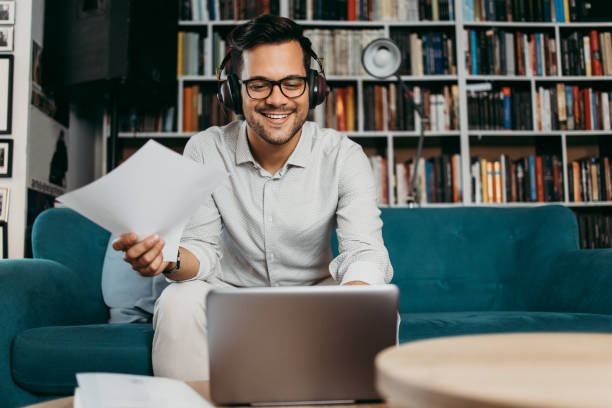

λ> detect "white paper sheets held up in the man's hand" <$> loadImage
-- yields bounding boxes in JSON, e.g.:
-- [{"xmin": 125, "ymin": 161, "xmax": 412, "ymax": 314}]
[{"xmin": 57, "ymin": 140, "xmax": 227, "ymax": 261}]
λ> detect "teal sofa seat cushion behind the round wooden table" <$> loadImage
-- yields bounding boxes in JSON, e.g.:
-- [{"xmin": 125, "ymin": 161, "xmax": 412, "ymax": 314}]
[{"xmin": 399, "ymin": 311, "xmax": 612, "ymax": 343}]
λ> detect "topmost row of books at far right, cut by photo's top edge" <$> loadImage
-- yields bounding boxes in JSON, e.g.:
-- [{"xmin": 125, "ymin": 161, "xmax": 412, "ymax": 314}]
[{"xmin": 463, "ymin": 0, "xmax": 609, "ymax": 23}]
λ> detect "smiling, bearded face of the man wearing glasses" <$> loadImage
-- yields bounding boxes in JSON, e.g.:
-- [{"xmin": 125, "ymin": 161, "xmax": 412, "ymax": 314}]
[{"xmin": 240, "ymin": 41, "xmax": 308, "ymax": 145}]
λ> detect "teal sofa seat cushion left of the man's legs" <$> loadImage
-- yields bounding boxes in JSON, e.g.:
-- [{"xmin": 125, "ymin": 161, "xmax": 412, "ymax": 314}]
[{"xmin": 12, "ymin": 324, "xmax": 153, "ymax": 395}]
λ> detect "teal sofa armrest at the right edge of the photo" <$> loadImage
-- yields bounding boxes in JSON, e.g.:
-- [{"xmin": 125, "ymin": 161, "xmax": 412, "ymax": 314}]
[{"xmin": 549, "ymin": 249, "xmax": 612, "ymax": 314}]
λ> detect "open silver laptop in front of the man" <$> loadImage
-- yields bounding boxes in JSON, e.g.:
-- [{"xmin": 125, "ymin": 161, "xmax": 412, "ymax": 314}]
[{"xmin": 206, "ymin": 285, "xmax": 399, "ymax": 405}]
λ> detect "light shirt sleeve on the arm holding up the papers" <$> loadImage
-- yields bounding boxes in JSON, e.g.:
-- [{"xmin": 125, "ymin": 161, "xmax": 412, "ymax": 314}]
[{"xmin": 169, "ymin": 138, "xmax": 223, "ymax": 281}]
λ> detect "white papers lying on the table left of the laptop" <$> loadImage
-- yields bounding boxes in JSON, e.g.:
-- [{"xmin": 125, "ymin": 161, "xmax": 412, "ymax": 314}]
[{"xmin": 75, "ymin": 373, "xmax": 213, "ymax": 408}]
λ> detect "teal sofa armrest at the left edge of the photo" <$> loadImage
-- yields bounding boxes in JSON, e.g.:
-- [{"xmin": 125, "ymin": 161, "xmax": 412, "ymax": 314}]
[{"xmin": 0, "ymin": 259, "xmax": 108, "ymax": 406}]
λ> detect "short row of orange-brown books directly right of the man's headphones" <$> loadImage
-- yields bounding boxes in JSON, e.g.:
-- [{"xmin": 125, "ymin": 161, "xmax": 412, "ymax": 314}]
[{"xmin": 309, "ymin": 85, "xmax": 357, "ymax": 132}]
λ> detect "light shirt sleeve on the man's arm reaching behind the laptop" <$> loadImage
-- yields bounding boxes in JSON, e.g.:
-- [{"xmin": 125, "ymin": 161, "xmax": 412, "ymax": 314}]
[{"xmin": 329, "ymin": 143, "xmax": 393, "ymax": 285}]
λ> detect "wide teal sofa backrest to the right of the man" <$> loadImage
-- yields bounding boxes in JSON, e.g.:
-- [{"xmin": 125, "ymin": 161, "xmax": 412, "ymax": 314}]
[{"xmin": 381, "ymin": 206, "xmax": 578, "ymax": 312}]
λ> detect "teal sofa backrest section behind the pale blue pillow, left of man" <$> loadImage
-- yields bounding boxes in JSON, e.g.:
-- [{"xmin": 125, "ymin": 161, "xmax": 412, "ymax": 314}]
[{"xmin": 32, "ymin": 208, "xmax": 110, "ymax": 320}]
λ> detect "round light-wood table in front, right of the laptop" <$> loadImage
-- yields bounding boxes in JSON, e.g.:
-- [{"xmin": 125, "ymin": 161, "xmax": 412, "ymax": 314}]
[{"xmin": 375, "ymin": 333, "xmax": 612, "ymax": 408}]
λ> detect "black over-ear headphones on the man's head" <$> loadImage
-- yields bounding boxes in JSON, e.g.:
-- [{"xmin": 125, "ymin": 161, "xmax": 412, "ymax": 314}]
[{"xmin": 217, "ymin": 50, "xmax": 329, "ymax": 115}]
